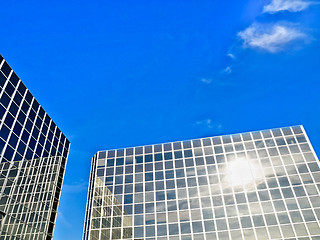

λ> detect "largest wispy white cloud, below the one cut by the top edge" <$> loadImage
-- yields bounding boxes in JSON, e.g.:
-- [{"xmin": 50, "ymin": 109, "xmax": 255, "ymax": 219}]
[{"xmin": 238, "ymin": 23, "xmax": 307, "ymax": 53}]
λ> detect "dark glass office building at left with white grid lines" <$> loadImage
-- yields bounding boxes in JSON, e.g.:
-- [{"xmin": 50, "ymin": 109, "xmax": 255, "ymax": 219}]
[{"xmin": 0, "ymin": 55, "xmax": 70, "ymax": 240}]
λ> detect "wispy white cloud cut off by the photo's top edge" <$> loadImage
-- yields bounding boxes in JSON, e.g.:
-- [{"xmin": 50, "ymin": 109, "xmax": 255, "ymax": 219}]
[{"xmin": 263, "ymin": 0, "xmax": 314, "ymax": 14}]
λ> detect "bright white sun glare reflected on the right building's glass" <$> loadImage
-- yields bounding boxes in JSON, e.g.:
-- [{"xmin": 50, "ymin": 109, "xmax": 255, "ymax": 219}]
[{"xmin": 226, "ymin": 158, "xmax": 262, "ymax": 187}]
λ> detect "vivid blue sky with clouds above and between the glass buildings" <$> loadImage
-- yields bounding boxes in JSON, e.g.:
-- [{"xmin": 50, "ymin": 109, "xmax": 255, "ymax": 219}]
[{"xmin": 0, "ymin": 0, "xmax": 320, "ymax": 240}]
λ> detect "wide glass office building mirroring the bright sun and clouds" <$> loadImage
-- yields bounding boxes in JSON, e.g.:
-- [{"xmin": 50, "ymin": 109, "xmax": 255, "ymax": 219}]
[{"xmin": 83, "ymin": 126, "xmax": 320, "ymax": 240}]
